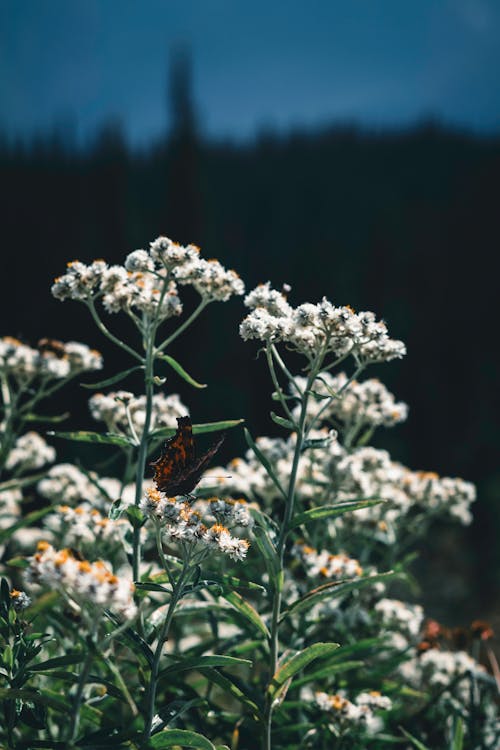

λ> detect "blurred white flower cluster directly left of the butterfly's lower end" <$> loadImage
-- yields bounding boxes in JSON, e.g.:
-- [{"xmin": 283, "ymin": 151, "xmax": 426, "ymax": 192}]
[{"xmin": 35, "ymin": 464, "xmax": 143, "ymax": 512}]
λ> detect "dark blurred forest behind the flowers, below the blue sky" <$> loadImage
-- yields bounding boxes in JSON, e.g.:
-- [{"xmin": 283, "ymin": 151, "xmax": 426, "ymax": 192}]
[{"xmin": 0, "ymin": 50, "xmax": 500, "ymax": 630}]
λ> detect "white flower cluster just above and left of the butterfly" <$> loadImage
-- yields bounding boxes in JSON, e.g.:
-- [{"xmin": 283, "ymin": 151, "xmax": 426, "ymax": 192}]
[{"xmin": 89, "ymin": 391, "xmax": 189, "ymax": 434}]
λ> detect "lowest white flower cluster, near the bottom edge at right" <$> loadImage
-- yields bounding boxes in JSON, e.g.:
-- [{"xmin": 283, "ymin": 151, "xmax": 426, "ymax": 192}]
[{"xmin": 315, "ymin": 690, "xmax": 392, "ymax": 734}]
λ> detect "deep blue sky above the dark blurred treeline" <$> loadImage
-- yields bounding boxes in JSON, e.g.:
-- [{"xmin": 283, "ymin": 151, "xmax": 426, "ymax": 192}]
[{"xmin": 0, "ymin": 0, "xmax": 500, "ymax": 144}]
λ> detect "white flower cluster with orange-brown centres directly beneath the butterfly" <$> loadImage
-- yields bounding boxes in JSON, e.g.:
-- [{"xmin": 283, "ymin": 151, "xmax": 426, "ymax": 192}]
[{"xmin": 139, "ymin": 489, "xmax": 250, "ymax": 560}]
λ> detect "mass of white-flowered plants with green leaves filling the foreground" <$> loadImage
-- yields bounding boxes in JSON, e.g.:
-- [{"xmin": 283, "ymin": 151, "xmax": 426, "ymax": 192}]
[{"xmin": 0, "ymin": 237, "xmax": 500, "ymax": 750}]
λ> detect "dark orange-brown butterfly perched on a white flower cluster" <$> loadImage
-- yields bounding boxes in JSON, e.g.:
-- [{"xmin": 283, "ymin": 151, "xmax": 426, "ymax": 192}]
[{"xmin": 151, "ymin": 417, "xmax": 226, "ymax": 497}]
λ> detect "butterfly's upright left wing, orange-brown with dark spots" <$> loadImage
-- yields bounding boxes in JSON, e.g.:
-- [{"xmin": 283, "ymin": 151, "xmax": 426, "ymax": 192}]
[{"xmin": 151, "ymin": 417, "xmax": 195, "ymax": 495}]
